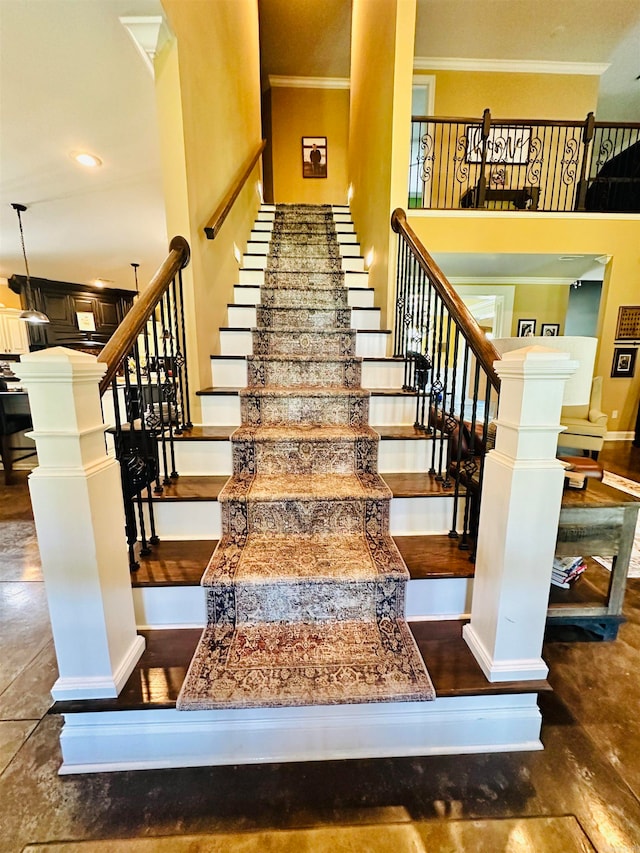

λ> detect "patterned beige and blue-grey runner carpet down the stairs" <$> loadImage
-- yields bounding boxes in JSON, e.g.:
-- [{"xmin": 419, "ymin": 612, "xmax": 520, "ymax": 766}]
[{"xmin": 177, "ymin": 205, "xmax": 435, "ymax": 710}]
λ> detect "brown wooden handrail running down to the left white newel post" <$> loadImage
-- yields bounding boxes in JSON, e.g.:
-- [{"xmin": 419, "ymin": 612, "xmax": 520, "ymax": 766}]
[{"xmin": 98, "ymin": 237, "xmax": 191, "ymax": 396}]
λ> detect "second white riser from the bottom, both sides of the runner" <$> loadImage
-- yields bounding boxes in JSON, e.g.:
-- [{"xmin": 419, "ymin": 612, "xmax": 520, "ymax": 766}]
[{"xmin": 133, "ymin": 572, "xmax": 473, "ymax": 630}]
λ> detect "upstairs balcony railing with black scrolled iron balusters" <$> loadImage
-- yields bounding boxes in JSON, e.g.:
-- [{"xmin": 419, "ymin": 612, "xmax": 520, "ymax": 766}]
[{"xmin": 408, "ymin": 109, "xmax": 640, "ymax": 213}]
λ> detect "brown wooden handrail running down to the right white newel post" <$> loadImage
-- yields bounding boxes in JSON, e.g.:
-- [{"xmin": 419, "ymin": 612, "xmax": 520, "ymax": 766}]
[{"xmin": 391, "ymin": 207, "xmax": 500, "ymax": 391}]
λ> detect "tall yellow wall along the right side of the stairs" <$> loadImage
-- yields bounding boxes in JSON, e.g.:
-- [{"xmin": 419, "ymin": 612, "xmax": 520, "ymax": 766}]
[{"xmin": 349, "ymin": 0, "xmax": 416, "ymax": 332}]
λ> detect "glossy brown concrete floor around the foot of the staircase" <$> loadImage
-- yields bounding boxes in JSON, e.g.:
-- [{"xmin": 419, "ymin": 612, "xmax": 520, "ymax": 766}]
[{"xmin": 0, "ymin": 443, "xmax": 640, "ymax": 853}]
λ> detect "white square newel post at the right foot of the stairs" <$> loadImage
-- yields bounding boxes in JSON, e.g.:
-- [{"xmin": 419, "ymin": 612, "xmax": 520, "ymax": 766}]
[{"xmin": 463, "ymin": 346, "xmax": 577, "ymax": 681}]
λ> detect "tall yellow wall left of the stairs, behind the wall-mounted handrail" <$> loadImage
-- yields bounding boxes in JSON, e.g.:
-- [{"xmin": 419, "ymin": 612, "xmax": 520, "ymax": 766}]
[{"xmin": 156, "ymin": 0, "xmax": 261, "ymax": 404}]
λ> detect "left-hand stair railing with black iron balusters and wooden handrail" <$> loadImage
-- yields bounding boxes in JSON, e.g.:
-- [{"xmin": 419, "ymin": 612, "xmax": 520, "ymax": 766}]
[{"xmin": 98, "ymin": 237, "xmax": 192, "ymax": 571}]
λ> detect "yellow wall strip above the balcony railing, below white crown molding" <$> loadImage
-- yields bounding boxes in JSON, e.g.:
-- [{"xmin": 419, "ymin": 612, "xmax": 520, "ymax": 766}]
[{"xmin": 416, "ymin": 71, "xmax": 599, "ymax": 120}]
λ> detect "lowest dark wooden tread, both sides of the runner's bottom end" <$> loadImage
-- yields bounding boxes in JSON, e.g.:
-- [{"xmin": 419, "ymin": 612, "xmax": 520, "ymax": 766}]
[{"xmin": 49, "ymin": 620, "xmax": 551, "ymax": 714}]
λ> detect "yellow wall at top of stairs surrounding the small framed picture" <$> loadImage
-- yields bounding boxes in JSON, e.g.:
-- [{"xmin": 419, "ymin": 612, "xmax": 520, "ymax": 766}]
[{"xmin": 271, "ymin": 86, "xmax": 349, "ymax": 204}]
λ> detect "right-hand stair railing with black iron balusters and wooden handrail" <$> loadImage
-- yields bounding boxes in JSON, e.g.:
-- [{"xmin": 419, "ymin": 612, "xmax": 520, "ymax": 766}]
[{"xmin": 391, "ymin": 208, "xmax": 500, "ymax": 557}]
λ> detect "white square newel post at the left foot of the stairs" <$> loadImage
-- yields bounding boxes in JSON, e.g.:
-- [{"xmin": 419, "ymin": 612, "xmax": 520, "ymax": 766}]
[{"xmin": 20, "ymin": 347, "xmax": 144, "ymax": 700}]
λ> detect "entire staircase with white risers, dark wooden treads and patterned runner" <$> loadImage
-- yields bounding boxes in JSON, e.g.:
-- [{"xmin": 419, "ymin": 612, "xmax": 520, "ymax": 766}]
[{"xmin": 54, "ymin": 201, "xmax": 546, "ymax": 773}]
